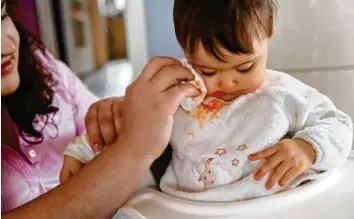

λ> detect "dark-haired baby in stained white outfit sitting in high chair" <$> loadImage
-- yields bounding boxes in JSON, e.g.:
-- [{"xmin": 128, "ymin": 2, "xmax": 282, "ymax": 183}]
[{"xmin": 59, "ymin": 0, "xmax": 353, "ymax": 202}]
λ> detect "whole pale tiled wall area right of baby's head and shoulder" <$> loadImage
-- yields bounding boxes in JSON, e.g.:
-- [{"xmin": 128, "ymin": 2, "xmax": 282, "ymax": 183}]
[{"xmin": 268, "ymin": 0, "xmax": 354, "ymax": 149}]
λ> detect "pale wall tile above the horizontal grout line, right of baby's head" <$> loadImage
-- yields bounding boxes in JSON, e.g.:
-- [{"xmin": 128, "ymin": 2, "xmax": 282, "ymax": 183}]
[{"xmin": 269, "ymin": 0, "xmax": 354, "ymax": 69}]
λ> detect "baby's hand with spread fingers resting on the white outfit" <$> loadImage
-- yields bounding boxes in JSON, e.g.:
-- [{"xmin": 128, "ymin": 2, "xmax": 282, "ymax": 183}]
[{"xmin": 248, "ymin": 139, "xmax": 316, "ymax": 189}]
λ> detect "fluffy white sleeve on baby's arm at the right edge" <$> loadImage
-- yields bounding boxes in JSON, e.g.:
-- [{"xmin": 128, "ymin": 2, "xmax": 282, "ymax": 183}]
[{"xmin": 285, "ymin": 79, "xmax": 353, "ymax": 171}]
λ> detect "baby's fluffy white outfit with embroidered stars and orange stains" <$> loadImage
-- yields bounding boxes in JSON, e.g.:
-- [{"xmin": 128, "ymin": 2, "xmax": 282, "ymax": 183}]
[{"xmin": 65, "ymin": 60, "xmax": 353, "ymax": 202}]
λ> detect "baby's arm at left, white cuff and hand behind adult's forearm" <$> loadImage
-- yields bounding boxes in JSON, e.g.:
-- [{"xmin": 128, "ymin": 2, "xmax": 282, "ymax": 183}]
[{"xmin": 59, "ymin": 132, "xmax": 97, "ymax": 183}]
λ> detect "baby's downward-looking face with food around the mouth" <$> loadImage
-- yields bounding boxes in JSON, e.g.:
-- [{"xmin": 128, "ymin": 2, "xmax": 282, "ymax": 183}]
[{"xmin": 185, "ymin": 39, "xmax": 269, "ymax": 101}]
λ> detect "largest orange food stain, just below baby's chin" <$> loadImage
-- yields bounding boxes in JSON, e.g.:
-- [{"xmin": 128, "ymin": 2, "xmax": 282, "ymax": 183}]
[{"xmin": 192, "ymin": 99, "xmax": 225, "ymax": 128}]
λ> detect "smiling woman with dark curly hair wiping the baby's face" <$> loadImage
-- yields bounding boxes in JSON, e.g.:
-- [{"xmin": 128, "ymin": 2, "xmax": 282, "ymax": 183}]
[{"xmin": 1, "ymin": 1, "xmax": 197, "ymax": 219}]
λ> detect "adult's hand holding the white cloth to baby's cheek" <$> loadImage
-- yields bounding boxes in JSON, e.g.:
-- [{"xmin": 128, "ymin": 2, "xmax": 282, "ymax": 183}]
[{"xmin": 119, "ymin": 57, "xmax": 199, "ymax": 161}]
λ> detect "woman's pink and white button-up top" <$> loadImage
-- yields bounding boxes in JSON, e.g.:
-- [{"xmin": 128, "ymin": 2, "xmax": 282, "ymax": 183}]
[{"xmin": 1, "ymin": 55, "xmax": 97, "ymax": 213}]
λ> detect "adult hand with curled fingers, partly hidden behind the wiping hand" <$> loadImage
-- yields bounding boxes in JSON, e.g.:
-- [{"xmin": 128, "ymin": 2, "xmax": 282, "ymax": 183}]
[{"xmin": 85, "ymin": 97, "xmax": 123, "ymax": 152}]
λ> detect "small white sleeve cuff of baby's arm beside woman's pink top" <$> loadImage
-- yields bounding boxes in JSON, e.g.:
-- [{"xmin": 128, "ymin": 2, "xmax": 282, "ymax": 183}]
[{"xmin": 64, "ymin": 132, "xmax": 97, "ymax": 164}]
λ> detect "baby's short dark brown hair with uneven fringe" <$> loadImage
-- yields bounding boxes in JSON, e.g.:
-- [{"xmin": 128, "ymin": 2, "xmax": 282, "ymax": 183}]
[{"xmin": 173, "ymin": 0, "xmax": 277, "ymax": 62}]
